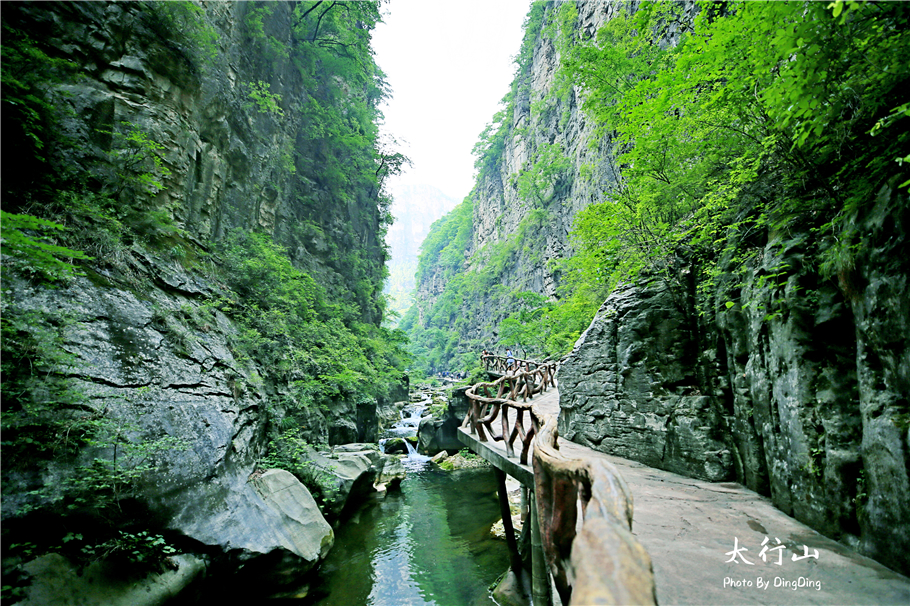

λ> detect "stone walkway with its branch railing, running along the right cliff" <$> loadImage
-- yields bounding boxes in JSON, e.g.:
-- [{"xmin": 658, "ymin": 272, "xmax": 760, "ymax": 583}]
[{"xmin": 458, "ymin": 356, "xmax": 910, "ymax": 606}]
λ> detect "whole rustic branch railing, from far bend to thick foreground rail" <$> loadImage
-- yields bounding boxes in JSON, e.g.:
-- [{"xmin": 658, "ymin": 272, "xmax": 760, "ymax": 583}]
[{"xmin": 462, "ymin": 355, "xmax": 657, "ymax": 605}]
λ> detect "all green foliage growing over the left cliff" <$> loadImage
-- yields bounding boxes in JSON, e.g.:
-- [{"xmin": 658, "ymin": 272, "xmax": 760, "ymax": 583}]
[{"xmin": 0, "ymin": 2, "xmax": 407, "ymax": 597}]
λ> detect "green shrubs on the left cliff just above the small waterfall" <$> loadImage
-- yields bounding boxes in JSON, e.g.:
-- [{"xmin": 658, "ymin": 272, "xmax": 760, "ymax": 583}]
[{"xmin": 219, "ymin": 230, "xmax": 407, "ymax": 415}]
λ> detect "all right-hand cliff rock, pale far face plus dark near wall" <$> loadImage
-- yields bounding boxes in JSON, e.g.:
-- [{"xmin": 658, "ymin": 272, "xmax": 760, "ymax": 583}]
[{"xmin": 405, "ymin": 2, "xmax": 910, "ymax": 571}]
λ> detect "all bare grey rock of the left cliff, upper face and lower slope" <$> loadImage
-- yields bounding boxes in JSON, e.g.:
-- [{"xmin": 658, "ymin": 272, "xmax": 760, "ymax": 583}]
[{"xmin": 3, "ymin": 2, "xmax": 398, "ymax": 588}]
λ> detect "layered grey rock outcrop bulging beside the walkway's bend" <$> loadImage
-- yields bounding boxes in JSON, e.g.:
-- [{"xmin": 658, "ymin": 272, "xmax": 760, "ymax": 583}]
[{"xmin": 558, "ymin": 282, "xmax": 735, "ymax": 481}]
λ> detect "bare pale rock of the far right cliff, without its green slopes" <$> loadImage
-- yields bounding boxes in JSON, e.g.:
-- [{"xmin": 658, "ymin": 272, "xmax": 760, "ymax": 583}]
[{"xmin": 416, "ymin": 0, "xmax": 621, "ymax": 346}]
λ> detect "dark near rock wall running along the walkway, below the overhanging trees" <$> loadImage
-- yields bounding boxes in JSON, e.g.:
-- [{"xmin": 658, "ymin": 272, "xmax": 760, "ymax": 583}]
[{"xmin": 558, "ymin": 179, "xmax": 910, "ymax": 573}]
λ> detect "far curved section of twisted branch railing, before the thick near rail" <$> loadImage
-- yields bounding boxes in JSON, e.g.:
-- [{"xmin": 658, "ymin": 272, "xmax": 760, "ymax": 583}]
[{"xmin": 461, "ymin": 364, "xmax": 556, "ymax": 465}]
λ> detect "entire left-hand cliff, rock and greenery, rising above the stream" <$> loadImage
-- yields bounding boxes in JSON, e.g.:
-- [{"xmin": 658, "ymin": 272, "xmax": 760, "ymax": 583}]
[{"xmin": 3, "ymin": 2, "xmax": 400, "ymax": 588}]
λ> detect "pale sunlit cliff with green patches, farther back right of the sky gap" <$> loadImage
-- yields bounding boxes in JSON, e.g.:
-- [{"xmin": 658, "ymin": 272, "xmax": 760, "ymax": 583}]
[{"xmin": 402, "ymin": 1, "xmax": 624, "ymax": 368}]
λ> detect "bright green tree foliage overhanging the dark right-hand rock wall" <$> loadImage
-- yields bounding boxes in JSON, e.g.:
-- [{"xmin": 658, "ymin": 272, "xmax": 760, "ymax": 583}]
[{"xmin": 563, "ymin": 2, "xmax": 910, "ymax": 318}]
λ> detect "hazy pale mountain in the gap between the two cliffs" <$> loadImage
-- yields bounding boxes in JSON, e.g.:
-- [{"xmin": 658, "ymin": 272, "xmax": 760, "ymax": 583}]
[{"xmin": 385, "ymin": 185, "xmax": 458, "ymax": 324}]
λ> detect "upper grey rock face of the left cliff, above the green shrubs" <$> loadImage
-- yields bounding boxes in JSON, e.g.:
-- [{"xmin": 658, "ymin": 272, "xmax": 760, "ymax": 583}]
[{"xmin": 10, "ymin": 2, "xmax": 385, "ymax": 322}]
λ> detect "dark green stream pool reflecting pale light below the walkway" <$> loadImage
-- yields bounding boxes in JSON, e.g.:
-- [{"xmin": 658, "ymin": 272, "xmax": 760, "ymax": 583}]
[{"xmin": 307, "ymin": 455, "xmax": 509, "ymax": 606}]
